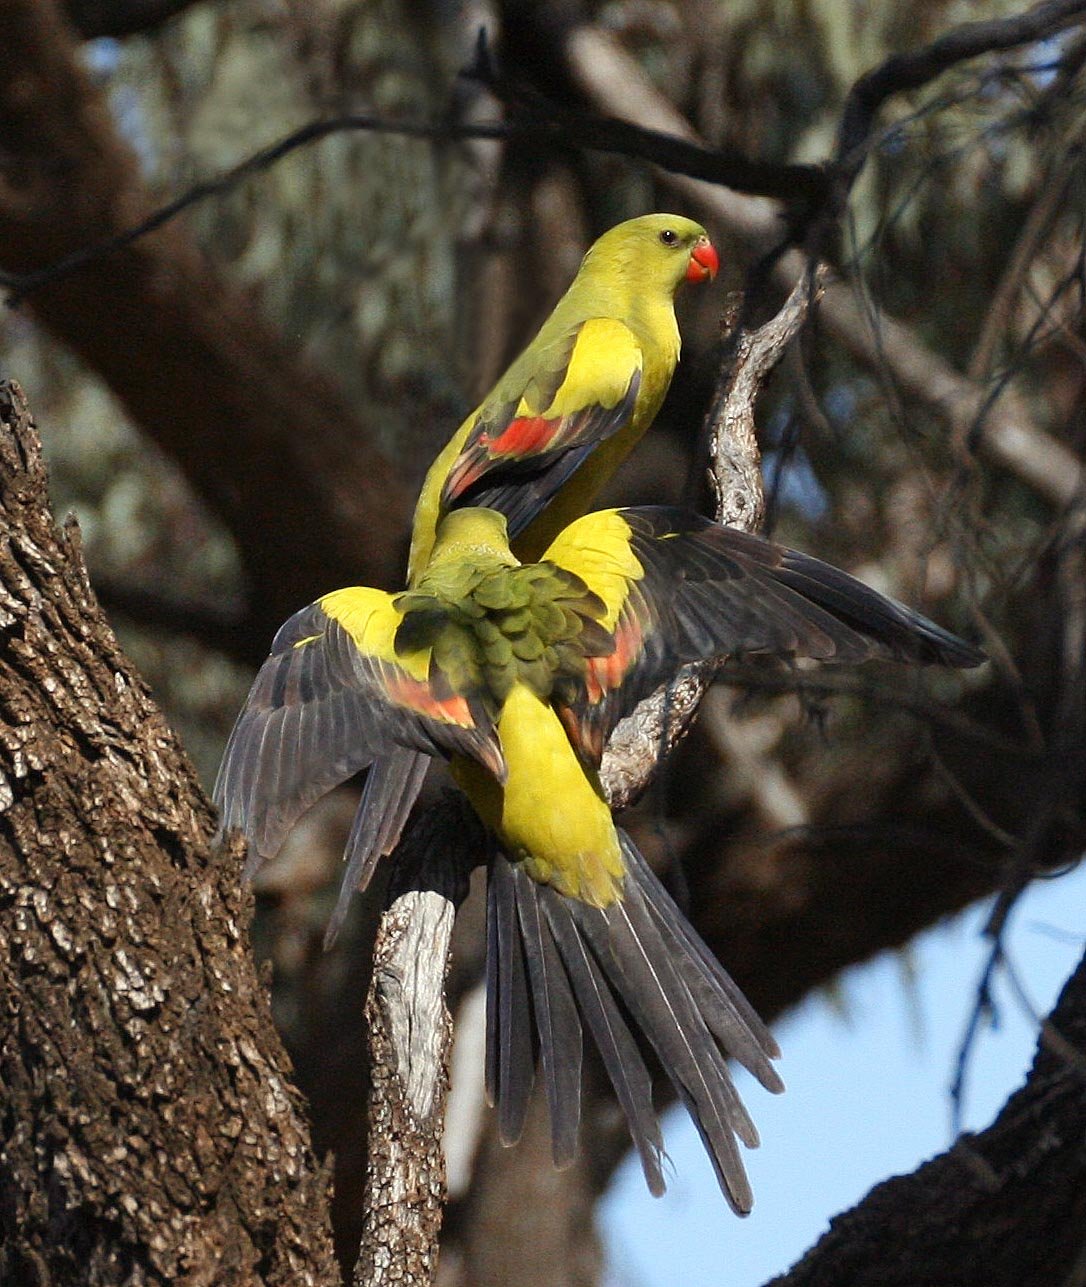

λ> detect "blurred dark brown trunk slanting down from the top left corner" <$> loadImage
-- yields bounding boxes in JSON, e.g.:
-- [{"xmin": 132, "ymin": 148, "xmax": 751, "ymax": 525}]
[{"xmin": 0, "ymin": 0, "xmax": 409, "ymax": 648}]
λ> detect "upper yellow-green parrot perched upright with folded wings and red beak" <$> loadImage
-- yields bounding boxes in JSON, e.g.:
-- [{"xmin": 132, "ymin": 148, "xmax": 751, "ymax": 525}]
[{"xmin": 347, "ymin": 215, "xmax": 719, "ymax": 900}]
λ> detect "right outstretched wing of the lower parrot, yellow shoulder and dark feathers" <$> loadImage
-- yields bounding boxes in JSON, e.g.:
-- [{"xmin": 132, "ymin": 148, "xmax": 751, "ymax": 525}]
[{"xmin": 544, "ymin": 507, "xmax": 984, "ymax": 762}]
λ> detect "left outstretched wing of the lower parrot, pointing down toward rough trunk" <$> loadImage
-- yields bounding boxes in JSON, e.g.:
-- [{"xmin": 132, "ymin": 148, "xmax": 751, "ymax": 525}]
[{"xmin": 214, "ymin": 587, "xmax": 504, "ymax": 875}]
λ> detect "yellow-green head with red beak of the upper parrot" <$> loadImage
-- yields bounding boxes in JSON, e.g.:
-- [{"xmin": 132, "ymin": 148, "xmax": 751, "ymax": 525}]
[{"xmin": 582, "ymin": 215, "xmax": 721, "ymax": 295}]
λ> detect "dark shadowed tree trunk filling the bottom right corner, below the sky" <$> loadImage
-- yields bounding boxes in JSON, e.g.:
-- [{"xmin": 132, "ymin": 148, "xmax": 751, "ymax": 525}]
[{"xmin": 773, "ymin": 958, "xmax": 1086, "ymax": 1287}]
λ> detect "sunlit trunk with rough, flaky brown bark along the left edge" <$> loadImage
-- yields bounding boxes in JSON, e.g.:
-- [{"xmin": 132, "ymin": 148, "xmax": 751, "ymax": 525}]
[{"xmin": 0, "ymin": 385, "xmax": 340, "ymax": 1287}]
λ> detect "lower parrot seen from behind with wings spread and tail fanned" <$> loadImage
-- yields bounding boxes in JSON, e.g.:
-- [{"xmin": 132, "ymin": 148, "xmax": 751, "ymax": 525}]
[{"xmin": 215, "ymin": 507, "xmax": 983, "ymax": 1212}]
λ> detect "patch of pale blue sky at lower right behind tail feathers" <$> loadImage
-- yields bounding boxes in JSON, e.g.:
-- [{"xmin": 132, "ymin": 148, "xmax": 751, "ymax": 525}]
[{"xmin": 601, "ymin": 865, "xmax": 1086, "ymax": 1287}]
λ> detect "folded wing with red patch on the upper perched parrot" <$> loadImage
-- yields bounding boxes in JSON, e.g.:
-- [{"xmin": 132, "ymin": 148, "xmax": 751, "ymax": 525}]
[{"xmin": 441, "ymin": 318, "xmax": 642, "ymax": 537}]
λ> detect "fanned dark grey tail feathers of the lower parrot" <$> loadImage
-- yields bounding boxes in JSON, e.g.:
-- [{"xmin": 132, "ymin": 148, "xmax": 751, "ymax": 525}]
[{"xmin": 486, "ymin": 833, "xmax": 784, "ymax": 1214}]
